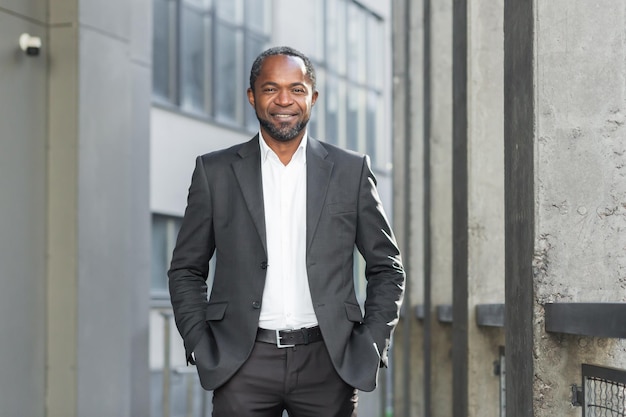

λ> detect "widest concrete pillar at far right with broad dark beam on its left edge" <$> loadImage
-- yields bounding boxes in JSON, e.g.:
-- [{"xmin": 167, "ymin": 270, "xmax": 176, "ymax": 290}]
[{"xmin": 504, "ymin": 0, "xmax": 626, "ymax": 417}]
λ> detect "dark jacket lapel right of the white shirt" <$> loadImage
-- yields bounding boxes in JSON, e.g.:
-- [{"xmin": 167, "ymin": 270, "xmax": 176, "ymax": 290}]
[{"xmin": 306, "ymin": 136, "xmax": 333, "ymax": 252}]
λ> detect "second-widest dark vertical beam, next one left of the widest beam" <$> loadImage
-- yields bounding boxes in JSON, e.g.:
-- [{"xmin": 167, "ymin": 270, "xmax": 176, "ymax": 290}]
[{"xmin": 452, "ymin": 0, "xmax": 468, "ymax": 417}]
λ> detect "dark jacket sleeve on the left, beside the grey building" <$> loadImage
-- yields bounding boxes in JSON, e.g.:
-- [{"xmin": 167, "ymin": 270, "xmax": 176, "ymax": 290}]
[{"xmin": 168, "ymin": 157, "xmax": 215, "ymax": 363}]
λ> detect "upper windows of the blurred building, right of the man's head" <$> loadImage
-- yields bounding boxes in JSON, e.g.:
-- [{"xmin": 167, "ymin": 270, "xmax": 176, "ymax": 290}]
[{"xmin": 315, "ymin": 0, "xmax": 386, "ymax": 167}]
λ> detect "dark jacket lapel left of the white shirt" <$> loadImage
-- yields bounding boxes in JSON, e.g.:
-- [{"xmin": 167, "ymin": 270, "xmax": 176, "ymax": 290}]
[{"xmin": 232, "ymin": 135, "xmax": 267, "ymax": 254}]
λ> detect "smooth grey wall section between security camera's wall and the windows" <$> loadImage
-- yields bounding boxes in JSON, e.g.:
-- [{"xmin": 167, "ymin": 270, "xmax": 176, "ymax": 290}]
[{"xmin": 46, "ymin": 0, "xmax": 152, "ymax": 417}]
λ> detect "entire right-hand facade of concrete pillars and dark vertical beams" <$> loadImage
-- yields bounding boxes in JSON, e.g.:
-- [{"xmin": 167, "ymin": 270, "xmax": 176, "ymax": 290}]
[{"xmin": 393, "ymin": 0, "xmax": 626, "ymax": 417}]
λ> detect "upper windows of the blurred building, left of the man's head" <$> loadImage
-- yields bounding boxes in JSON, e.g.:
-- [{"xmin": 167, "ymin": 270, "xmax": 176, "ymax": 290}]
[{"xmin": 152, "ymin": 0, "xmax": 271, "ymax": 131}]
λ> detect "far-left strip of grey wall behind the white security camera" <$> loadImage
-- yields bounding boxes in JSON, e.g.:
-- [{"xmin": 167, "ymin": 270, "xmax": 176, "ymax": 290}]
[{"xmin": 0, "ymin": 0, "xmax": 48, "ymax": 417}]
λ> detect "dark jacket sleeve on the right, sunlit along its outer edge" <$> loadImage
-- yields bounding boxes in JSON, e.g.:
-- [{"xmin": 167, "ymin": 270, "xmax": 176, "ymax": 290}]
[{"xmin": 356, "ymin": 157, "xmax": 405, "ymax": 366}]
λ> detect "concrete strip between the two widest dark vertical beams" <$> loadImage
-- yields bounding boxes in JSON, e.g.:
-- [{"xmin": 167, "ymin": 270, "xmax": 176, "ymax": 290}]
[{"xmin": 467, "ymin": 0, "xmax": 504, "ymax": 417}]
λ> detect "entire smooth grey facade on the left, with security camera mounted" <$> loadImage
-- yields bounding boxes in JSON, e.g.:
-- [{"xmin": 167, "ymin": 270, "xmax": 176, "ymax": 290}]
[{"xmin": 0, "ymin": 0, "xmax": 152, "ymax": 417}]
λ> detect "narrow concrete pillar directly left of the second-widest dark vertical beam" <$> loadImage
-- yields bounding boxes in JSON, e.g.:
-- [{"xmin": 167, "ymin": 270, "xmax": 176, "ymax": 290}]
[{"xmin": 423, "ymin": 0, "xmax": 453, "ymax": 417}]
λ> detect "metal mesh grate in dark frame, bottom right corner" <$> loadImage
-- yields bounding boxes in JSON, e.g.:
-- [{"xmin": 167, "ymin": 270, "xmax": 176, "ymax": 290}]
[{"xmin": 582, "ymin": 364, "xmax": 626, "ymax": 417}]
